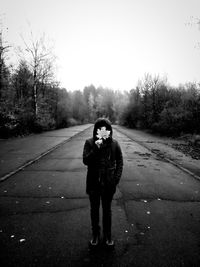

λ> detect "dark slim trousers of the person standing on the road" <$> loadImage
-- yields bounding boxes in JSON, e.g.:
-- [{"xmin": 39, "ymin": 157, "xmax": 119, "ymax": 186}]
[{"xmin": 89, "ymin": 192, "xmax": 114, "ymax": 239}]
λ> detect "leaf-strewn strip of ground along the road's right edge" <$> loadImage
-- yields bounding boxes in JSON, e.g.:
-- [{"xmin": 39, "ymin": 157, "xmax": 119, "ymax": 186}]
[{"xmin": 114, "ymin": 126, "xmax": 200, "ymax": 180}]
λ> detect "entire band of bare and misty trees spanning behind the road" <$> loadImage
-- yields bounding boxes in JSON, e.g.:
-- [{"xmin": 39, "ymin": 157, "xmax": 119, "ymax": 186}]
[{"xmin": 0, "ymin": 28, "xmax": 200, "ymax": 138}]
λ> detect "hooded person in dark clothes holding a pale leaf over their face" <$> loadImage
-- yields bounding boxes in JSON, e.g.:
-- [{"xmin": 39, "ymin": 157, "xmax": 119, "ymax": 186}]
[{"xmin": 83, "ymin": 118, "xmax": 123, "ymax": 246}]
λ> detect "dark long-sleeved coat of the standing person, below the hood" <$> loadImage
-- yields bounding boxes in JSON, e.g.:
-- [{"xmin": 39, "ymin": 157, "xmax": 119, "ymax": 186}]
[{"xmin": 83, "ymin": 138, "xmax": 123, "ymax": 194}]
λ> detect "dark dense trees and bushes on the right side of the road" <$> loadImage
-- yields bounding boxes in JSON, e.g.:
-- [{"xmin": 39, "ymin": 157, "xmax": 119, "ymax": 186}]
[{"xmin": 122, "ymin": 74, "xmax": 200, "ymax": 136}]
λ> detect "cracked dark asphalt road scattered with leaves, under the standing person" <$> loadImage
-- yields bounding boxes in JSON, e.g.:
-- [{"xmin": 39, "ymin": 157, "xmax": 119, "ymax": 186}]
[{"xmin": 0, "ymin": 127, "xmax": 200, "ymax": 267}]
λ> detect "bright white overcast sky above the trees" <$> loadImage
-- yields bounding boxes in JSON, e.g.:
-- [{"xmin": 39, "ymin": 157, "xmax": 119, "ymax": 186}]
[{"xmin": 0, "ymin": 0, "xmax": 200, "ymax": 90}]
